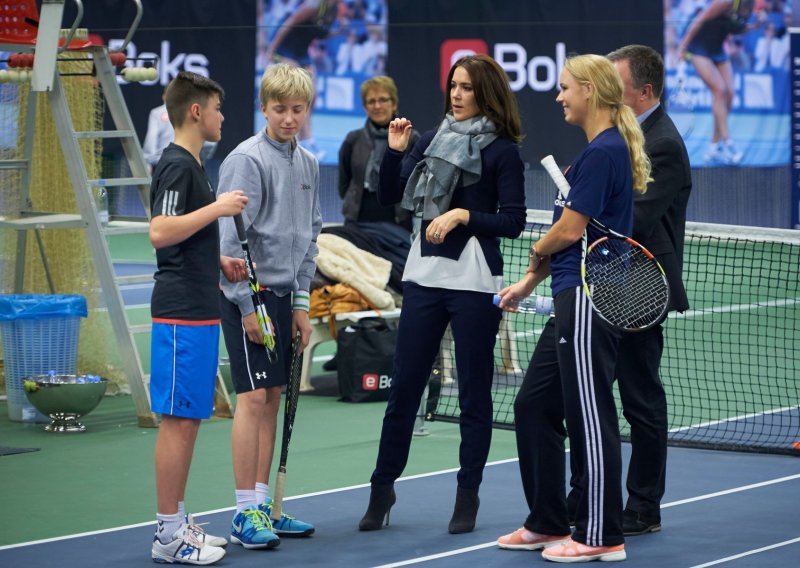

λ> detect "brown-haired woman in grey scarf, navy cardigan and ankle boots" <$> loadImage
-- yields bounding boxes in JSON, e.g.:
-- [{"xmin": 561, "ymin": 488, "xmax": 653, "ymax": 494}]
[{"xmin": 359, "ymin": 55, "xmax": 525, "ymax": 533}]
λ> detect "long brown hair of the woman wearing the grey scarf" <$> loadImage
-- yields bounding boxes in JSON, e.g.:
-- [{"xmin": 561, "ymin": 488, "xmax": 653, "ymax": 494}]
[{"xmin": 444, "ymin": 53, "xmax": 522, "ymax": 143}]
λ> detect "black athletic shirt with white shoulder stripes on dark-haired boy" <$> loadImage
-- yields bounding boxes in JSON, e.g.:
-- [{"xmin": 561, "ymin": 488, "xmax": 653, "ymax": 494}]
[{"xmin": 150, "ymin": 144, "xmax": 220, "ymax": 321}]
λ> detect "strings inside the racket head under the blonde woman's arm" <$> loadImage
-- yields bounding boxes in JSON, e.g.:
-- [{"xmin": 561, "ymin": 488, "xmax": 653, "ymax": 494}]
[{"xmin": 585, "ymin": 239, "xmax": 669, "ymax": 330}]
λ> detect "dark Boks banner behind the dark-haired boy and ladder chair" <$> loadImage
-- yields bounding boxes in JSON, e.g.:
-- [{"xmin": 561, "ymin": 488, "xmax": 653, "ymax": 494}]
[{"xmin": 81, "ymin": 0, "xmax": 256, "ymax": 158}]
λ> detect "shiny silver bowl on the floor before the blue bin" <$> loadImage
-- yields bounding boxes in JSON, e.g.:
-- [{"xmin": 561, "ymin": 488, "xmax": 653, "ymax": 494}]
[{"xmin": 22, "ymin": 375, "xmax": 108, "ymax": 432}]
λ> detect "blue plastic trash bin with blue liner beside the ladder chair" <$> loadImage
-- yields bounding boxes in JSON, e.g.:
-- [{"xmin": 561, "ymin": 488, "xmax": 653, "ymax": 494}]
[{"xmin": 0, "ymin": 294, "xmax": 88, "ymax": 422}]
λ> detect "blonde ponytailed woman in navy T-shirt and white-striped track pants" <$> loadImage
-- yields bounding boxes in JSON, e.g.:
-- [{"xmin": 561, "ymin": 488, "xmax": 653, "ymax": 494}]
[{"xmin": 498, "ymin": 55, "xmax": 650, "ymax": 562}]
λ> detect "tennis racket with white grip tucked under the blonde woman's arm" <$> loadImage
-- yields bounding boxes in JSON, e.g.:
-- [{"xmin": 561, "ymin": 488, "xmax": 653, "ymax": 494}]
[{"xmin": 542, "ymin": 156, "xmax": 669, "ymax": 331}]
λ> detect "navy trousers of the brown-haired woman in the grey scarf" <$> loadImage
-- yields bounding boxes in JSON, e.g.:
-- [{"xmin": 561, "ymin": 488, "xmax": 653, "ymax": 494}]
[{"xmin": 371, "ymin": 282, "xmax": 502, "ymax": 489}]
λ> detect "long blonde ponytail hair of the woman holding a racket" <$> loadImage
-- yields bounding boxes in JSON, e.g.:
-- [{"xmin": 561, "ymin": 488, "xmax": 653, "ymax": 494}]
[{"xmin": 564, "ymin": 54, "xmax": 653, "ymax": 193}]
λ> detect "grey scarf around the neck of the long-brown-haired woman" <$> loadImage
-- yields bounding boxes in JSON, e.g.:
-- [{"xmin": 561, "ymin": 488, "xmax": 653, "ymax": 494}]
[{"xmin": 400, "ymin": 113, "xmax": 497, "ymax": 220}]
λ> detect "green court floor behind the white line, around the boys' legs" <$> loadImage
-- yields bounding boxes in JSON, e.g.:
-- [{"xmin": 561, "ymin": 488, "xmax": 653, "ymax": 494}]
[{"xmin": 0, "ymin": 388, "xmax": 516, "ymax": 546}]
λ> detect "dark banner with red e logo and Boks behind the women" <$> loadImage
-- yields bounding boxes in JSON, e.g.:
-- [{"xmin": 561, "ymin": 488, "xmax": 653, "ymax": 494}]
[{"xmin": 388, "ymin": 0, "xmax": 664, "ymax": 167}]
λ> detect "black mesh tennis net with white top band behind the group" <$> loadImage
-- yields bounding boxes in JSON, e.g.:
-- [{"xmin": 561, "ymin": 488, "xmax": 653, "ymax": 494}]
[{"xmin": 432, "ymin": 211, "xmax": 800, "ymax": 454}]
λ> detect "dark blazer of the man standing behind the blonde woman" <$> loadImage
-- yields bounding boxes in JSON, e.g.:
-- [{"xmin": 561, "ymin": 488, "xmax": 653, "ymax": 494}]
[{"xmin": 633, "ymin": 106, "xmax": 692, "ymax": 312}]
